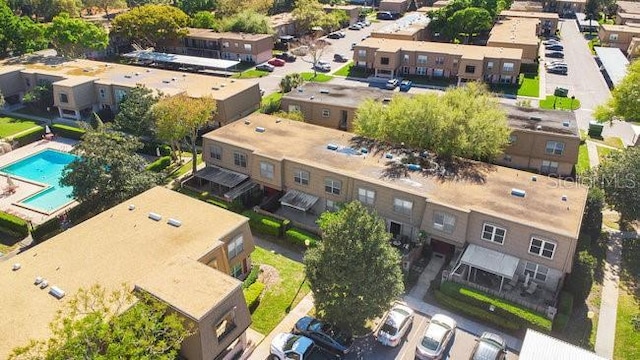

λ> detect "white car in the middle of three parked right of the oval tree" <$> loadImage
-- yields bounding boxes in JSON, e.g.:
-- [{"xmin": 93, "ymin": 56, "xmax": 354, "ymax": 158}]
[{"xmin": 416, "ymin": 314, "xmax": 456, "ymax": 360}]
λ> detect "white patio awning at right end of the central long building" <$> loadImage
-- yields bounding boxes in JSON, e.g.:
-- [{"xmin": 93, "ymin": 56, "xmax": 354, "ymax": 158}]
[{"xmin": 460, "ymin": 244, "xmax": 520, "ymax": 279}]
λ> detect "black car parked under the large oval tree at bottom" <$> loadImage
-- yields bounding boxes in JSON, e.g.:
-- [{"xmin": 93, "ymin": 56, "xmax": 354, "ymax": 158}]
[{"xmin": 293, "ymin": 316, "xmax": 353, "ymax": 356}]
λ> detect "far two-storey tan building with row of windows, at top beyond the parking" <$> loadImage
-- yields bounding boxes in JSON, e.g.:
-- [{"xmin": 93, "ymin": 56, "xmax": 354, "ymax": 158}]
[{"xmin": 353, "ymin": 38, "xmax": 522, "ymax": 84}]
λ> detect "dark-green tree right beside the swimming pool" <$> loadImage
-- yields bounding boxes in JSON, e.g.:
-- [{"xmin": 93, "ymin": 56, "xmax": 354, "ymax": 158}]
[{"xmin": 60, "ymin": 129, "xmax": 158, "ymax": 208}]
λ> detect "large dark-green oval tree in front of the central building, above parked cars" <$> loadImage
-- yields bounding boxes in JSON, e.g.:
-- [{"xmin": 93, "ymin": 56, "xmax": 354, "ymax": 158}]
[{"xmin": 304, "ymin": 201, "xmax": 404, "ymax": 332}]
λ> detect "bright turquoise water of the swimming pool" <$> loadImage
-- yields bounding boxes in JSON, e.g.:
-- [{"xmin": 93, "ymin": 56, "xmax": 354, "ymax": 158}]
[{"xmin": 0, "ymin": 150, "xmax": 77, "ymax": 213}]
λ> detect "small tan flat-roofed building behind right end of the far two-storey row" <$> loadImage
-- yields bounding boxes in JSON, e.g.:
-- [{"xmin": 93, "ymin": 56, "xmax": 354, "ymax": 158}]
[{"xmin": 487, "ymin": 17, "xmax": 542, "ymax": 64}]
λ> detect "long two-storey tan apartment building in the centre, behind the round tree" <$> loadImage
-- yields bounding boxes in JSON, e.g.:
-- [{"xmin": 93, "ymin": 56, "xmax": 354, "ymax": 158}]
[{"xmin": 203, "ymin": 114, "xmax": 587, "ymax": 298}]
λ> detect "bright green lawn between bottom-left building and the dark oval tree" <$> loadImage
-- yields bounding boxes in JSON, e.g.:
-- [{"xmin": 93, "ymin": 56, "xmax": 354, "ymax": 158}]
[{"xmin": 251, "ymin": 247, "xmax": 309, "ymax": 335}]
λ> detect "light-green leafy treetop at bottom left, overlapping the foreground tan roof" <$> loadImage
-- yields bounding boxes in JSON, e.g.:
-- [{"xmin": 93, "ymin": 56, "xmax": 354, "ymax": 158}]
[{"xmin": 9, "ymin": 285, "xmax": 192, "ymax": 360}]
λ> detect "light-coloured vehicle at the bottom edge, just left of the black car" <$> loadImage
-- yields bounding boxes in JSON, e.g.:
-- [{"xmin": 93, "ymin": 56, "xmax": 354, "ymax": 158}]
[{"xmin": 271, "ymin": 333, "xmax": 335, "ymax": 360}]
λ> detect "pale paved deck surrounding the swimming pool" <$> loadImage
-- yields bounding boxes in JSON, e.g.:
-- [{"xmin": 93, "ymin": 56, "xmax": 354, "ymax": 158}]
[{"xmin": 0, "ymin": 137, "xmax": 77, "ymax": 225}]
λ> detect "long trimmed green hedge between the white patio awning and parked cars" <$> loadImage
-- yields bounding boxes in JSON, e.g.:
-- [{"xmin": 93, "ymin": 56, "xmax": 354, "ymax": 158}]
[{"xmin": 440, "ymin": 281, "xmax": 551, "ymax": 331}]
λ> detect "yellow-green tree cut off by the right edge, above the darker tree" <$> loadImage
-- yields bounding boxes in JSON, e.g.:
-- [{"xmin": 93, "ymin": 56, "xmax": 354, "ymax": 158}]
[{"xmin": 594, "ymin": 60, "xmax": 640, "ymax": 122}]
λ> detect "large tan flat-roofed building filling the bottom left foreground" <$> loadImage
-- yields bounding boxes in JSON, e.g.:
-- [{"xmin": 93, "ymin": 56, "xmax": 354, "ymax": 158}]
[{"xmin": 0, "ymin": 187, "xmax": 254, "ymax": 360}]
